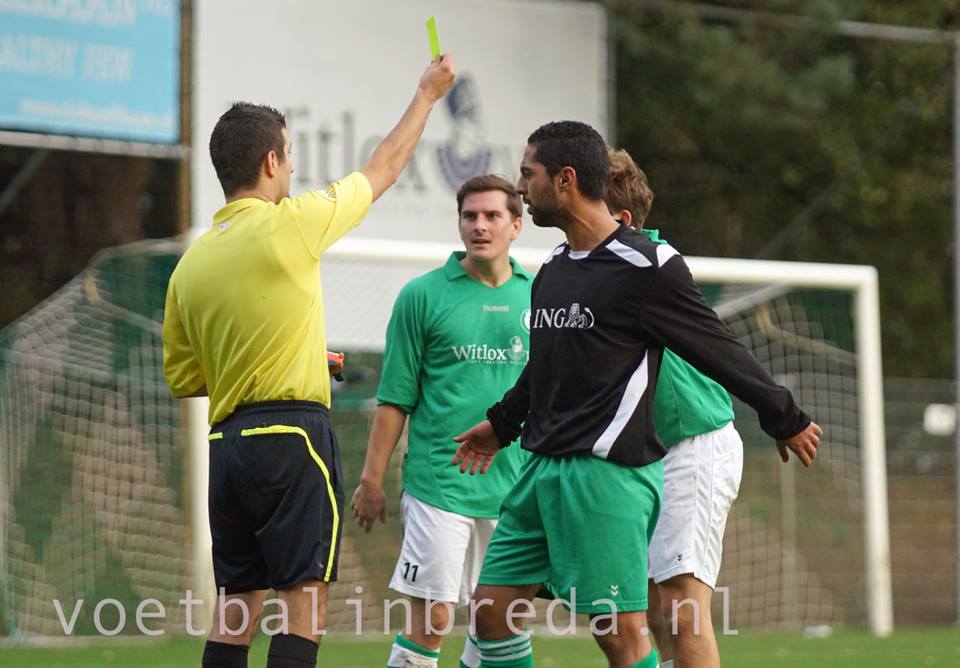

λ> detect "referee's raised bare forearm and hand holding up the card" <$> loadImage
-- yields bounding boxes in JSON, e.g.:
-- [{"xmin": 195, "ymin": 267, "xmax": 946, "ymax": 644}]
[{"xmin": 360, "ymin": 53, "xmax": 454, "ymax": 202}]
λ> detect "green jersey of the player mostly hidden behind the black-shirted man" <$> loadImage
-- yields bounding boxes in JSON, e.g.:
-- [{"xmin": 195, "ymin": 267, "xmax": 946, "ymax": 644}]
[{"xmin": 643, "ymin": 230, "xmax": 733, "ymax": 448}]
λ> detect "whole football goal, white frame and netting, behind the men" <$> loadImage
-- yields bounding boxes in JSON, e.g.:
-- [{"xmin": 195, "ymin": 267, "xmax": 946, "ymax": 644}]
[{"xmin": 0, "ymin": 238, "xmax": 892, "ymax": 636}]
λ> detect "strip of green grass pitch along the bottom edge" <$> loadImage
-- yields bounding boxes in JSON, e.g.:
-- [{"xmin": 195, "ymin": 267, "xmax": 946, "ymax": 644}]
[{"xmin": 0, "ymin": 628, "xmax": 960, "ymax": 668}]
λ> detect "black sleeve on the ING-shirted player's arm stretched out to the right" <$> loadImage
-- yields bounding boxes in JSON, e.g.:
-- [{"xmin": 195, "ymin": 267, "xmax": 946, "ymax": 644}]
[{"xmin": 638, "ymin": 255, "xmax": 811, "ymax": 440}]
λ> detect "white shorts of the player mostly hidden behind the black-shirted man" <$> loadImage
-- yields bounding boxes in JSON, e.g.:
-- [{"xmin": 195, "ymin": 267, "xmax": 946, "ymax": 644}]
[{"xmin": 649, "ymin": 422, "xmax": 743, "ymax": 587}]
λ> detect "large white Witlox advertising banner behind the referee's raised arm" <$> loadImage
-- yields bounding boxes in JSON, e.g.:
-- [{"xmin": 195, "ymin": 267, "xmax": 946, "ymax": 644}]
[{"xmin": 193, "ymin": 0, "xmax": 608, "ymax": 248}]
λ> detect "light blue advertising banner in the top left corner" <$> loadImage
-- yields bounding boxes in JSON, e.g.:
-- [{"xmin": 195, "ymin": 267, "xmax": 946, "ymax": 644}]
[{"xmin": 0, "ymin": 0, "xmax": 180, "ymax": 143}]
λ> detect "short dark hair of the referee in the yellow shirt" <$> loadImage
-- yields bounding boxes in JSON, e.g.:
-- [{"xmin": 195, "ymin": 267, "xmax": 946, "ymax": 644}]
[{"xmin": 210, "ymin": 102, "xmax": 287, "ymax": 197}]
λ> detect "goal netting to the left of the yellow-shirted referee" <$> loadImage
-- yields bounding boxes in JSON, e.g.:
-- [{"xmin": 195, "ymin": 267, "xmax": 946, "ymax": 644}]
[{"xmin": 0, "ymin": 242, "xmax": 190, "ymax": 637}]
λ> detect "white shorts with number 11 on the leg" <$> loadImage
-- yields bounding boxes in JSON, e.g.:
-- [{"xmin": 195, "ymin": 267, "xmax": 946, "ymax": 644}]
[{"xmin": 390, "ymin": 492, "xmax": 497, "ymax": 605}]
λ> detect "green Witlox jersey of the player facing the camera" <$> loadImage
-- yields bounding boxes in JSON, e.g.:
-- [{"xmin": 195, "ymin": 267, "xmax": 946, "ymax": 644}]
[{"xmin": 377, "ymin": 252, "xmax": 533, "ymax": 518}]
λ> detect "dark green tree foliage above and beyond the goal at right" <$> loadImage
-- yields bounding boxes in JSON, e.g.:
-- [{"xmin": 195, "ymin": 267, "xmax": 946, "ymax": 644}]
[{"xmin": 606, "ymin": 0, "xmax": 960, "ymax": 377}]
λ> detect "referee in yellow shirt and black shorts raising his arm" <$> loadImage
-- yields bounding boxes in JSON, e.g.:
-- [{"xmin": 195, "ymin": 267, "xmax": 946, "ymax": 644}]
[{"xmin": 163, "ymin": 55, "xmax": 454, "ymax": 668}]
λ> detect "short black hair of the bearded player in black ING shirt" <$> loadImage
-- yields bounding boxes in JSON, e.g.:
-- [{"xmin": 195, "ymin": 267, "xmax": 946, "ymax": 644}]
[{"xmin": 527, "ymin": 121, "xmax": 610, "ymax": 200}]
